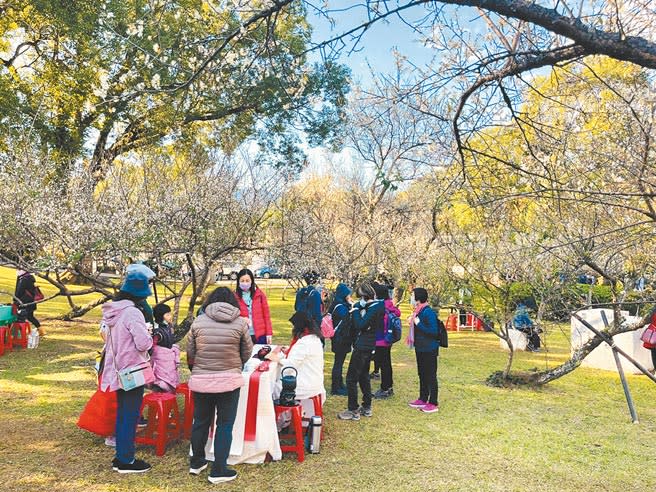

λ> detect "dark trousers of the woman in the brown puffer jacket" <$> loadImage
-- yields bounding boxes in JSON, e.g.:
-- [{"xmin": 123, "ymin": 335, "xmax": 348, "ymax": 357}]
[{"xmin": 191, "ymin": 388, "xmax": 239, "ymax": 473}]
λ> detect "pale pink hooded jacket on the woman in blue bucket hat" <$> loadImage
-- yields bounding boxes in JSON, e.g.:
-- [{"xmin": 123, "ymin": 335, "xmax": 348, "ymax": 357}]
[{"xmin": 101, "ymin": 300, "xmax": 153, "ymax": 391}]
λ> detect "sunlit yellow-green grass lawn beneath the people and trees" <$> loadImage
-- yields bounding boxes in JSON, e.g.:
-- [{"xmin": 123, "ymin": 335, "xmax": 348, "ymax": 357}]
[{"xmin": 0, "ymin": 272, "xmax": 656, "ymax": 492}]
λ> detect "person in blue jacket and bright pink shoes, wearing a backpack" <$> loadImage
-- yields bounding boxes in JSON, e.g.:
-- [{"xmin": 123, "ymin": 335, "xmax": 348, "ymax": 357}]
[{"xmin": 406, "ymin": 287, "xmax": 440, "ymax": 413}]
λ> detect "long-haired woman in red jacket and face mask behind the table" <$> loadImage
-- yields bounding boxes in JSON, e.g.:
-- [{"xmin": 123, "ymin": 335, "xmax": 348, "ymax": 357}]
[{"xmin": 235, "ymin": 268, "xmax": 273, "ymax": 344}]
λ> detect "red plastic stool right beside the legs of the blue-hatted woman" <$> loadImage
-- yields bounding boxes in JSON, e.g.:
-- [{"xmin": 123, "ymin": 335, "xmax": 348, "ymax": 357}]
[{"xmin": 135, "ymin": 393, "xmax": 180, "ymax": 456}]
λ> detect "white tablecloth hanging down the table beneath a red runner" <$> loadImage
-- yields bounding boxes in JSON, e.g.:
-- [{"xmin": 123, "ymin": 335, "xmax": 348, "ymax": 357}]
[{"xmin": 189, "ymin": 345, "xmax": 282, "ymax": 465}]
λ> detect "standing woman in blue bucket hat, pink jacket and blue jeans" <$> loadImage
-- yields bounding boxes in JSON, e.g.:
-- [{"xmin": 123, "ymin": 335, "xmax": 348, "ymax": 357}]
[{"xmin": 101, "ymin": 270, "xmax": 153, "ymax": 473}]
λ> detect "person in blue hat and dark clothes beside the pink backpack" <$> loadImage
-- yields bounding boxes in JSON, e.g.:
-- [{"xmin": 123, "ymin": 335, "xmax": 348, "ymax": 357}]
[{"xmin": 328, "ymin": 283, "xmax": 353, "ymax": 396}]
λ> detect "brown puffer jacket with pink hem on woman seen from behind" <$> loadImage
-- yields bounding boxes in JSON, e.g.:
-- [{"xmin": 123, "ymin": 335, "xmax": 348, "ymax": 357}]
[{"xmin": 187, "ymin": 302, "xmax": 253, "ymax": 393}]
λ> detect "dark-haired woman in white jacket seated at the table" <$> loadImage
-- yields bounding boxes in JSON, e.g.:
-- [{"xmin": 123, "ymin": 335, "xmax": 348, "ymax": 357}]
[{"xmin": 267, "ymin": 312, "xmax": 326, "ymax": 414}]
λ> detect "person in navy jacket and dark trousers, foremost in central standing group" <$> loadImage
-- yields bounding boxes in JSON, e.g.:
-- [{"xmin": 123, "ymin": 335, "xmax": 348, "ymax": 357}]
[{"xmin": 337, "ymin": 283, "xmax": 385, "ymax": 420}]
